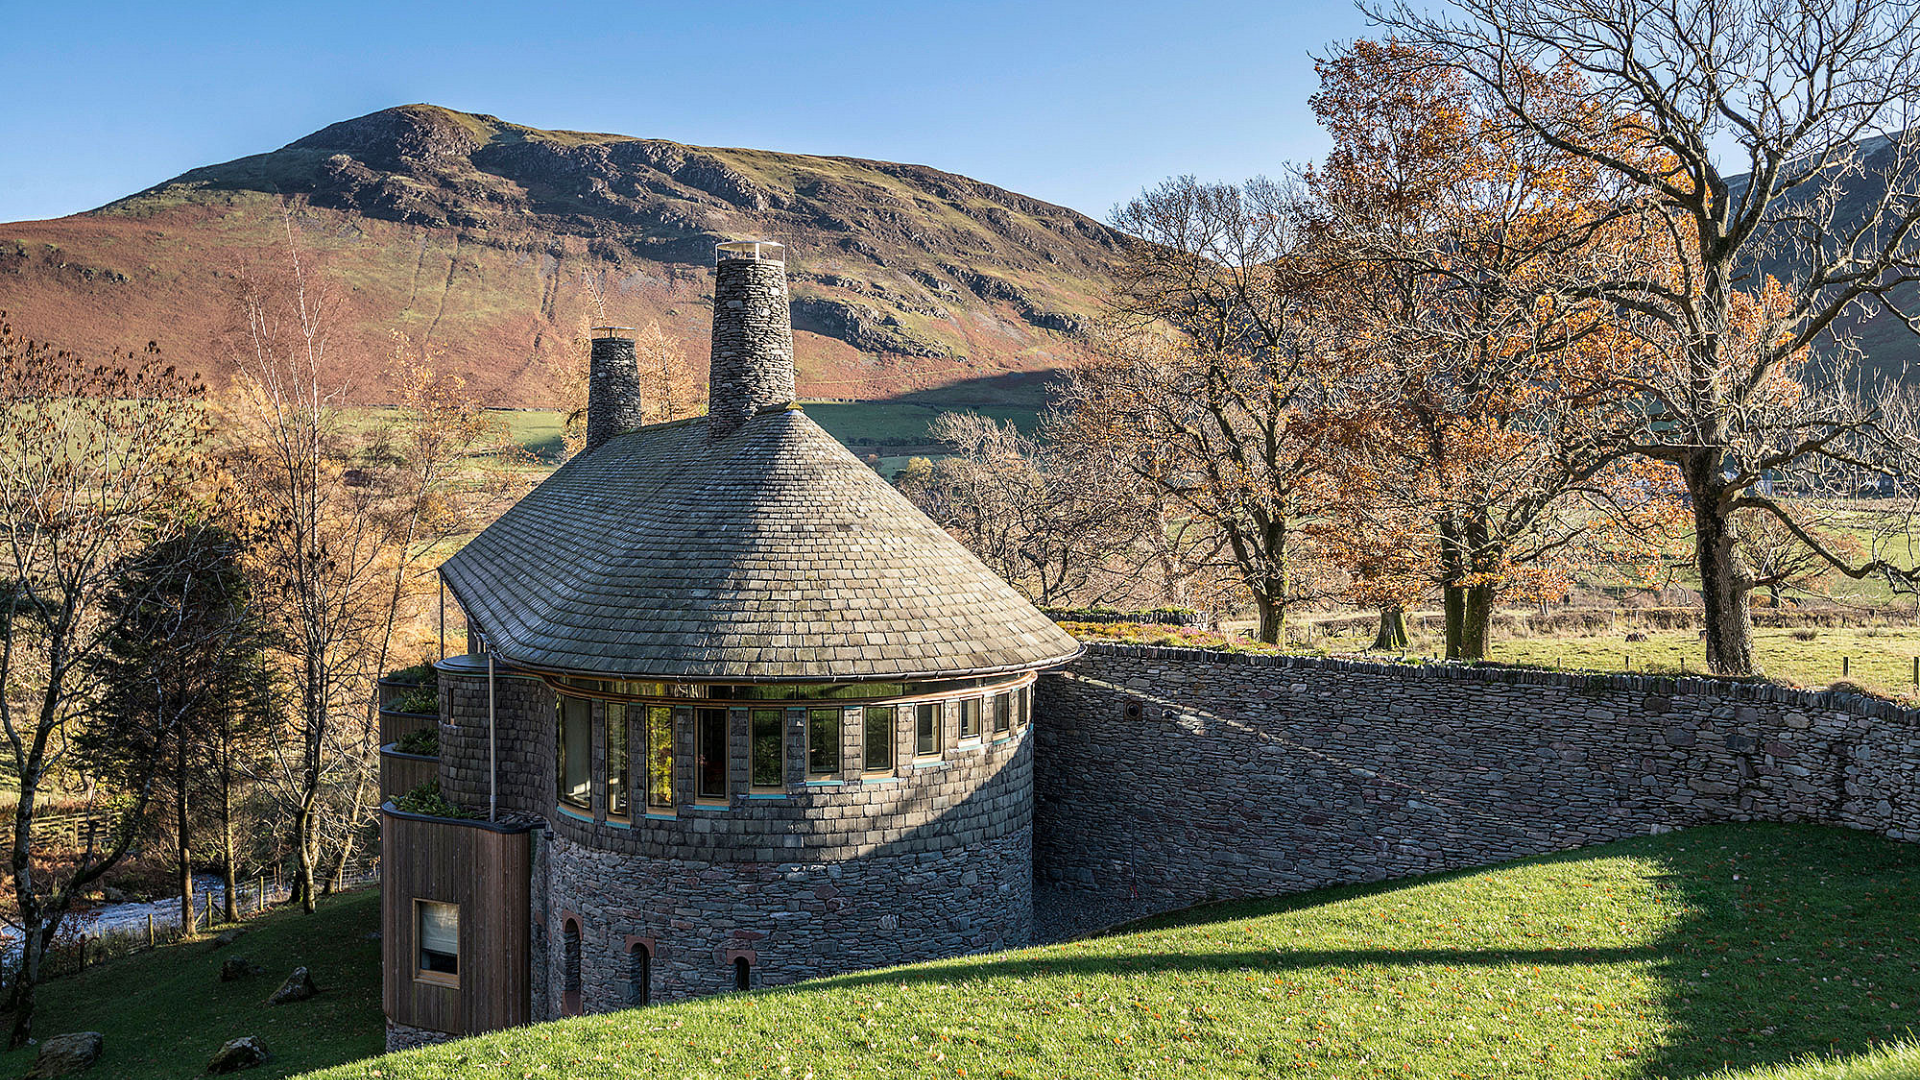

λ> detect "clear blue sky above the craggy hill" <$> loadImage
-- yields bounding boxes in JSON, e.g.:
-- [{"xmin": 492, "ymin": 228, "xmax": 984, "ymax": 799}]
[{"xmin": 0, "ymin": 0, "xmax": 1367, "ymax": 221}]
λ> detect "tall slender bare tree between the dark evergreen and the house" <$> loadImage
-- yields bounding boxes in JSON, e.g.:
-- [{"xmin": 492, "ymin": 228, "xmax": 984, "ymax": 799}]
[{"xmin": 223, "ymin": 215, "xmax": 394, "ymax": 913}]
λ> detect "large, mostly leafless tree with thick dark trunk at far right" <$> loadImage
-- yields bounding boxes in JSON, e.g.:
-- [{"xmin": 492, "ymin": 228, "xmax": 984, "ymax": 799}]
[{"xmin": 1365, "ymin": 0, "xmax": 1920, "ymax": 675}]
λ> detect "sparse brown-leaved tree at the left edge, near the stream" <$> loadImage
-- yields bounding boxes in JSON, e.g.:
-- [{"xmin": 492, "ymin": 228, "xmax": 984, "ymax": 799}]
[{"xmin": 0, "ymin": 317, "xmax": 205, "ymax": 1047}]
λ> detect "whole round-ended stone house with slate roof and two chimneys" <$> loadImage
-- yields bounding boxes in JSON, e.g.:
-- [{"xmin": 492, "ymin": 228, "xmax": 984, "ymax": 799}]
[{"xmin": 382, "ymin": 242, "xmax": 1081, "ymax": 1047}]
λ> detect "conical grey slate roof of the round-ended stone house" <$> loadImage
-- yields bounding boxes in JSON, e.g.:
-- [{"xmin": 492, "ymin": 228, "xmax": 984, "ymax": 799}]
[{"xmin": 440, "ymin": 405, "xmax": 1079, "ymax": 682}]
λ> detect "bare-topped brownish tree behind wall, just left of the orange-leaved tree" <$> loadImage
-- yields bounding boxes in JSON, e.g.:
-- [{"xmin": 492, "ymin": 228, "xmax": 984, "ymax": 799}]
[{"xmin": 1060, "ymin": 177, "xmax": 1334, "ymax": 642}]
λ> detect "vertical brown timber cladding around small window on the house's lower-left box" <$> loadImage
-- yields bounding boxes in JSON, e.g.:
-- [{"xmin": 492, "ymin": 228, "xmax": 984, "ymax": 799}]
[{"xmin": 380, "ymin": 805, "xmax": 532, "ymax": 1034}]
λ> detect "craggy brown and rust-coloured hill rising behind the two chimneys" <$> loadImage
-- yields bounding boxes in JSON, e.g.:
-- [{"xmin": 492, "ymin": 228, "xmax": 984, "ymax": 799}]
[{"xmin": 0, "ymin": 106, "xmax": 1117, "ymax": 405}]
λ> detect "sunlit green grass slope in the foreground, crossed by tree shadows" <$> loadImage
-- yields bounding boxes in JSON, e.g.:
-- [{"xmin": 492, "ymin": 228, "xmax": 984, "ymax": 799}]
[{"xmin": 303, "ymin": 824, "xmax": 1920, "ymax": 1080}]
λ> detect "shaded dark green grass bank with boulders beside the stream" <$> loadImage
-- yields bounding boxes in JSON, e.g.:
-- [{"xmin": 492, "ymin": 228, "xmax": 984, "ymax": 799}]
[{"xmin": 0, "ymin": 888, "xmax": 386, "ymax": 1080}]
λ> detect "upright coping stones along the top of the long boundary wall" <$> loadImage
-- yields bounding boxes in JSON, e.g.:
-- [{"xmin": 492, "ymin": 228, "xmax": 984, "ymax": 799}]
[{"xmin": 1087, "ymin": 642, "xmax": 1920, "ymax": 726}]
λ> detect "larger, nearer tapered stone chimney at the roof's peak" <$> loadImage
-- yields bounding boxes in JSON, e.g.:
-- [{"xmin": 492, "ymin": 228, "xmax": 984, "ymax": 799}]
[{"xmin": 707, "ymin": 240, "xmax": 793, "ymax": 438}]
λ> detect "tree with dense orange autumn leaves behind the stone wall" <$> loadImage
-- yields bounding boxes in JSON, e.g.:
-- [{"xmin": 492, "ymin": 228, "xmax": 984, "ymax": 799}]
[{"xmin": 1304, "ymin": 40, "xmax": 1640, "ymax": 659}]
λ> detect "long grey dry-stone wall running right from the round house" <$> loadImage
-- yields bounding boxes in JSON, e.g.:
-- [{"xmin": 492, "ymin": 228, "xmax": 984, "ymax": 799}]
[{"xmin": 1035, "ymin": 644, "xmax": 1920, "ymax": 911}]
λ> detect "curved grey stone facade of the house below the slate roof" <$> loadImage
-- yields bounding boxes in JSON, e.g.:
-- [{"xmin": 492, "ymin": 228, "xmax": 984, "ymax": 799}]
[{"xmin": 440, "ymin": 645, "xmax": 1035, "ymax": 1017}]
